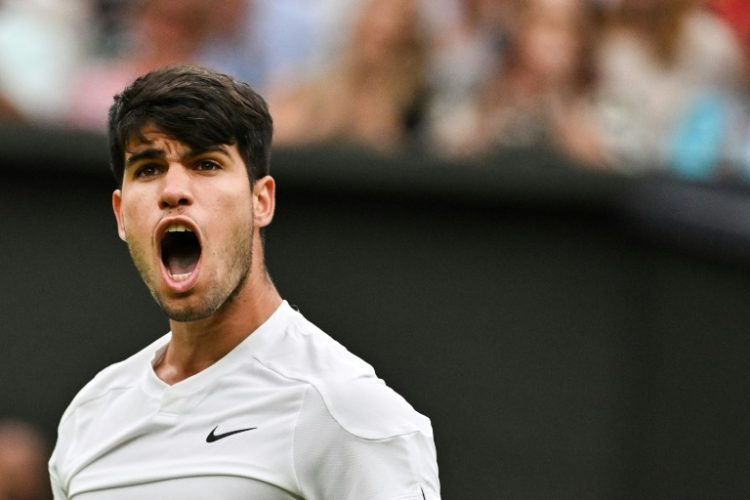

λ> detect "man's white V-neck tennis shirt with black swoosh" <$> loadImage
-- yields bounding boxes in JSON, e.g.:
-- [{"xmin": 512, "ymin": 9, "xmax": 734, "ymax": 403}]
[{"xmin": 50, "ymin": 302, "xmax": 440, "ymax": 500}]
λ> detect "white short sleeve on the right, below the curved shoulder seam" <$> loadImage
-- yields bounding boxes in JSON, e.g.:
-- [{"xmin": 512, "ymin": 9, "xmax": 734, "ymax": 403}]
[{"xmin": 294, "ymin": 387, "xmax": 440, "ymax": 500}]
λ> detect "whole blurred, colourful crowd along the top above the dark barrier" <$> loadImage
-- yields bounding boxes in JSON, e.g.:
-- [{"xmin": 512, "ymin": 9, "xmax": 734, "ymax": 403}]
[{"xmin": 0, "ymin": 0, "xmax": 750, "ymax": 180}]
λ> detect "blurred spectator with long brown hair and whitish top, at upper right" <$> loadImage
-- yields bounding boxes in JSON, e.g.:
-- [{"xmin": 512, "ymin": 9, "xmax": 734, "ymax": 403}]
[{"xmin": 592, "ymin": 0, "xmax": 741, "ymax": 173}]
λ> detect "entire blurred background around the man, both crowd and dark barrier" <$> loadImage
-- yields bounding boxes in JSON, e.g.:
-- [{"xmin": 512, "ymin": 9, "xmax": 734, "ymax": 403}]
[{"xmin": 0, "ymin": 0, "xmax": 750, "ymax": 500}]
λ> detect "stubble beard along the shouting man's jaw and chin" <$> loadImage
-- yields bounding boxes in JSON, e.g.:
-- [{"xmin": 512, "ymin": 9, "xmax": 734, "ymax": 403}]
[{"xmin": 128, "ymin": 228, "xmax": 253, "ymax": 322}]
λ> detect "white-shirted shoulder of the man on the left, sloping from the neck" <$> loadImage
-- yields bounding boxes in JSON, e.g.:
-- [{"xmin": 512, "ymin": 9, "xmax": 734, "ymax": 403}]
[{"xmin": 60, "ymin": 334, "xmax": 169, "ymax": 425}]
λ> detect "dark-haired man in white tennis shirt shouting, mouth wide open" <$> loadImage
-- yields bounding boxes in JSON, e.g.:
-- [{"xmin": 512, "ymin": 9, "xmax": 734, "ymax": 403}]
[{"xmin": 50, "ymin": 66, "xmax": 440, "ymax": 500}]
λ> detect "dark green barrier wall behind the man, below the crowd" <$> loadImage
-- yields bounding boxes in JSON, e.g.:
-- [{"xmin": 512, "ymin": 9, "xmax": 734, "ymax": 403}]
[{"xmin": 0, "ymin": 123, "xmax": 750, "ymax": 500}]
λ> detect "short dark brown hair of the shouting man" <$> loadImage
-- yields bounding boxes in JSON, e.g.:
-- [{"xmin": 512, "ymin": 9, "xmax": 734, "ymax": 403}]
[{"xmin": 104, "ymin": 65, "xmax": 273, "ymax": 185}]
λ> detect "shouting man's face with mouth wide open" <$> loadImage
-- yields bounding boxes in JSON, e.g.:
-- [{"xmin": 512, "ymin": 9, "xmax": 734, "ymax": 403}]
[{"xmin": 112, "ymin": 125, "xmax": 264, "ymax": 321}]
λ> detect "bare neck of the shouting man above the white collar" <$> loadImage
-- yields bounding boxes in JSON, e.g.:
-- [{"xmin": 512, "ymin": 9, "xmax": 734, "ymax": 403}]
[{"xmin": 154, "ymin": 258, "xmax": 282, "ymax": 385}]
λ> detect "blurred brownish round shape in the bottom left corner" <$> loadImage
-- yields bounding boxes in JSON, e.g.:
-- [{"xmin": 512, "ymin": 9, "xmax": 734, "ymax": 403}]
[{"xmin": 0, "ymin": 420, "xmax": 52, "ymax": 500}]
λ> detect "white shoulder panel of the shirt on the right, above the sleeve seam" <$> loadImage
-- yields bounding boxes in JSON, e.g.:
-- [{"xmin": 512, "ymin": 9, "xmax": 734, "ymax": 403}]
[{"xmin": 259, "ymin": 311, "xmax": 432, "ymax": 439}]
